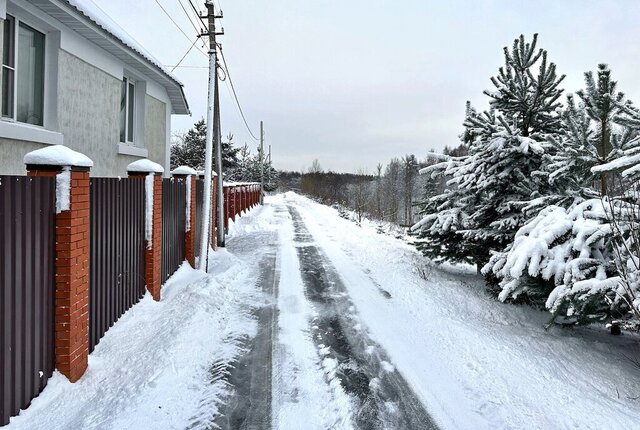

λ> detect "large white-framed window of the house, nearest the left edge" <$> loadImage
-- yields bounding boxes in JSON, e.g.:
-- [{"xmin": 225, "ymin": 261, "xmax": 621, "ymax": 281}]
[{"xmin": 2, "ymin": 15, "xmax": 45, "ymax": 125}]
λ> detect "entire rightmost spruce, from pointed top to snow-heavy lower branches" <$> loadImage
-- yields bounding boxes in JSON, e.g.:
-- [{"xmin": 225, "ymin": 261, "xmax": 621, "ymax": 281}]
[{"xmin": 486, "ymin": 64, "xmax": 640, "ymax": 322}]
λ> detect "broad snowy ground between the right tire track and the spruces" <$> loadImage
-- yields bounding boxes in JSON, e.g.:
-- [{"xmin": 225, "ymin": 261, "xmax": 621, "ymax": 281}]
[{"xmin": 282, "ymin": 194, "xmax": 640, "ymax": 430}]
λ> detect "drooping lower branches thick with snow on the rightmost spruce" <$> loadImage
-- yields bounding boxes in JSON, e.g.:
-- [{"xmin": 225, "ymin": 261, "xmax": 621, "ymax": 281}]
[{"xmin": 483, "ymin": 198, "xmax": 639, "ymax": 321}]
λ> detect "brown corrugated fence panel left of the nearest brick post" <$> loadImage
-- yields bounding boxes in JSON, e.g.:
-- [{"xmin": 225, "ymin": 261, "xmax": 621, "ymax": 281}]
[{"xmin": 0, "ymin": 176, "xmax": 55, "ymax": 425}]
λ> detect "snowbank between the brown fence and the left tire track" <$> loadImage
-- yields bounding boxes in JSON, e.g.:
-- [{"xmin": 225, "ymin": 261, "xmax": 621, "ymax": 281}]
[{"xmin": 6, "ymin": 237, "xmax": 261, "ymax": 430}]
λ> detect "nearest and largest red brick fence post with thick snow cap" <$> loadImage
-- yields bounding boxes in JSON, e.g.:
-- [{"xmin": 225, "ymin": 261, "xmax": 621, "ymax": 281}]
[{"xmin": 24, "ymin": 145, "xmax": 93, "ymax": 382}]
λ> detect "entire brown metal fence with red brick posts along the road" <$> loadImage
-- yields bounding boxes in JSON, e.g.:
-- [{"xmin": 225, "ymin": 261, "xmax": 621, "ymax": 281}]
[{"xmin": 0, "ymin": 166, "xmax": 260, "ymax": 426}]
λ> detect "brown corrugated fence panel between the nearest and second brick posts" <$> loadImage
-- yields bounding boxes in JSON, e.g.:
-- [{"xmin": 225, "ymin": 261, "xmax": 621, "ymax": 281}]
[{"xmin": 89, "ymin": 178, "xmax": 145, "ymax": 351}]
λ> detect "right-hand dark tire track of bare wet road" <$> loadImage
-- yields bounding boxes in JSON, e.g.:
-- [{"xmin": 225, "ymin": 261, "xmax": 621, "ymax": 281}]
[{"xmin": 288, "ymin": 205, "xmax": 437, "ymax": 429}]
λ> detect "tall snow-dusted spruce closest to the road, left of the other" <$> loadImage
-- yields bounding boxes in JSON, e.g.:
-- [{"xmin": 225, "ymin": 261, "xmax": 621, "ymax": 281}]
[{"xmin": 414, "ymin": 35, "xmax": 564, "ymax": 267}]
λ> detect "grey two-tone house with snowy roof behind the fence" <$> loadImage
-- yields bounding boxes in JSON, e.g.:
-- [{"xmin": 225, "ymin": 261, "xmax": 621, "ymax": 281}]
[{"xmin": 0, "ymin": 0, "xmax": 190, "ymax": 177}]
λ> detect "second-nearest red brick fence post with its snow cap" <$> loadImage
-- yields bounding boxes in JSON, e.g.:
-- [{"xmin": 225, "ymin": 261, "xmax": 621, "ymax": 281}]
[{"xmin": 127, "ymin": 159, "xmax": 164, "ymax": 301}]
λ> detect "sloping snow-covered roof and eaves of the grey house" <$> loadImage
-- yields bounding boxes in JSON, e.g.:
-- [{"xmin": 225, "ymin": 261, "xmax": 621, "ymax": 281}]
[{"xmin": 30, "ymin": 0, "xmax": 191, "ymax": 115}]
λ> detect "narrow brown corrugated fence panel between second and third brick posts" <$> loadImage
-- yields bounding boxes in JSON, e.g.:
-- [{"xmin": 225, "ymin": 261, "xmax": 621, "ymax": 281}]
[{"xmin": 161, "ymin": 179, "xmax": 187, "ymax": 284}]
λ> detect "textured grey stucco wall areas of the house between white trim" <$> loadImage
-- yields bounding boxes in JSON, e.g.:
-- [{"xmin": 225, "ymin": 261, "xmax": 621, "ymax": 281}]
[{"xmin": 0, "ymin": 19, "xmax": 168, "ymax": 177}]
